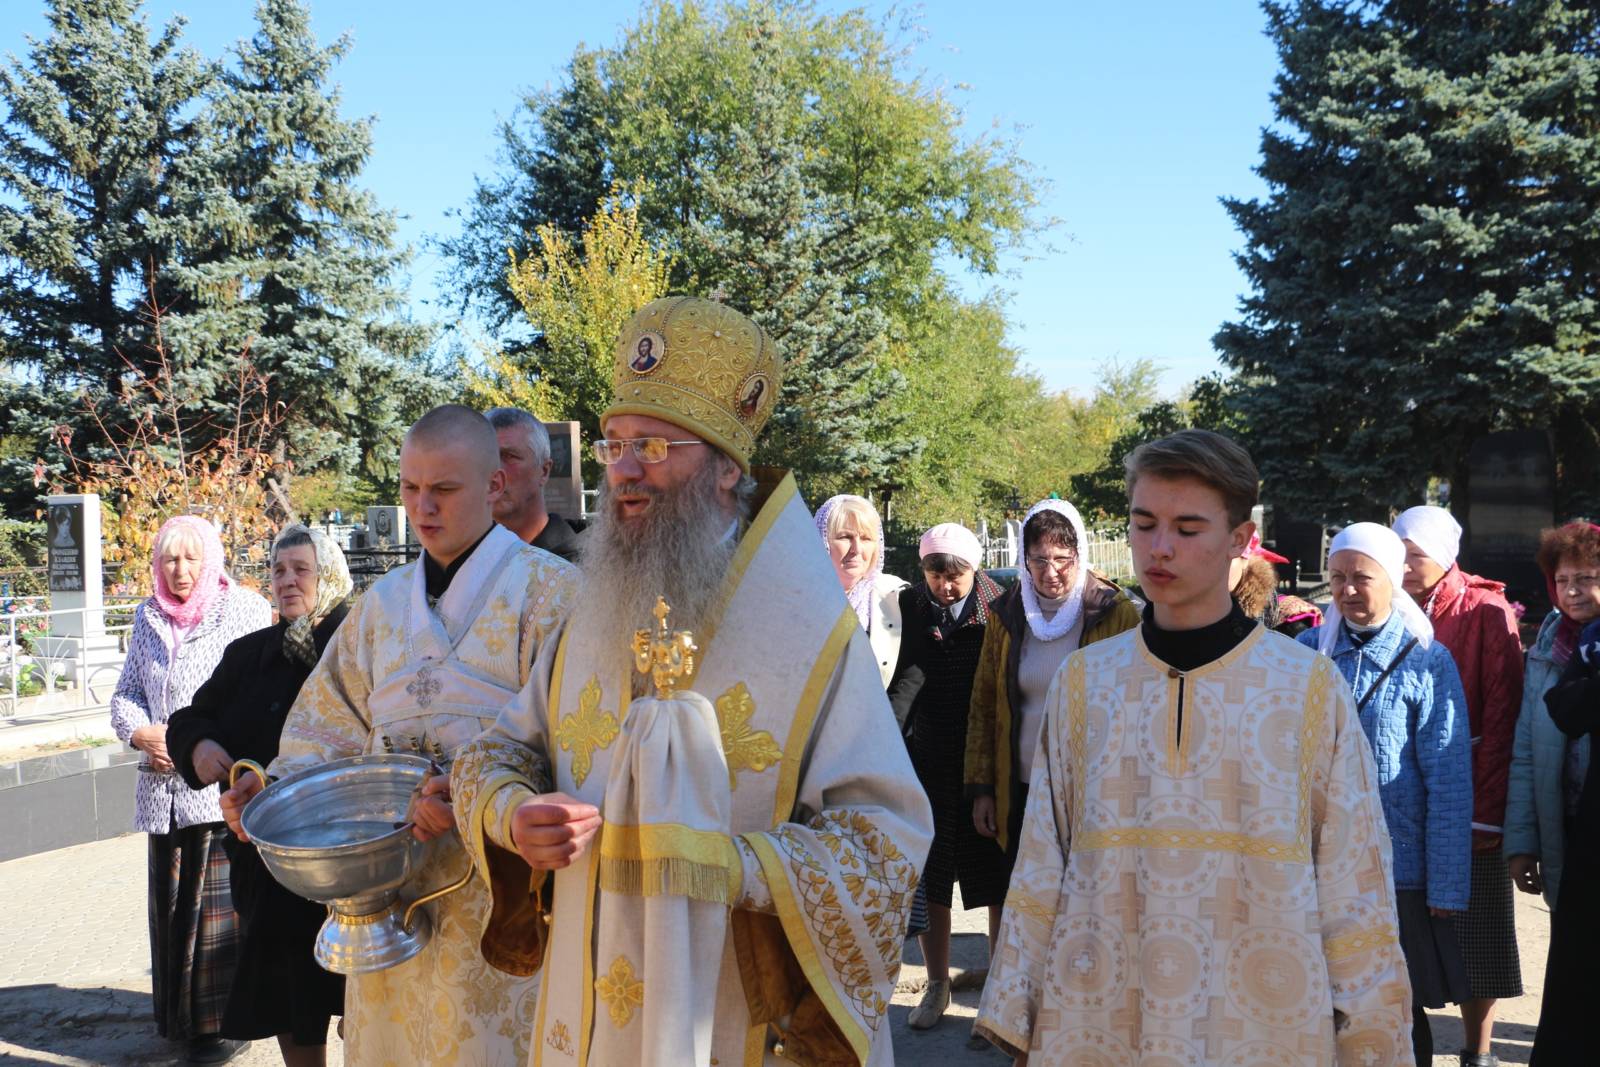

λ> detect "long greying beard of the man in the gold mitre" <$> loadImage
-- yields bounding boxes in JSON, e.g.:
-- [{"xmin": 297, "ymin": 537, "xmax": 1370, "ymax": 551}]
[{"xmin": 571, "ymin": 464, "xmax": 738, "ymax": 677}]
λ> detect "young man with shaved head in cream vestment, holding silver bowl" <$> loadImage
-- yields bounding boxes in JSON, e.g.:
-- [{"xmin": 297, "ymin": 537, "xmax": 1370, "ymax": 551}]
[{"xmin": 224, "ymin": 405, "xmax": 576, "ymax": 1067}]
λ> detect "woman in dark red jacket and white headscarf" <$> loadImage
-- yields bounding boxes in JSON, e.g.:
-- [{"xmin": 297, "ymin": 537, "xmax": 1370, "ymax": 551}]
[{"xmin": 1394, "ymin": 507, "xmax": 1522, "ymax": 1067}]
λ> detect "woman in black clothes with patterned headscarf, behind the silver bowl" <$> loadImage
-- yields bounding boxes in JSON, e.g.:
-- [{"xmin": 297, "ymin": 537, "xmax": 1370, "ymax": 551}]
[{"xmin": 166, "ymin": 525, "xmax": 350, "ymax": 1067}]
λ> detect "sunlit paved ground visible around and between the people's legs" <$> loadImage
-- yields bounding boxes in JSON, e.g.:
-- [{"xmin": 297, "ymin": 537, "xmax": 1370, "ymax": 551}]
[{"xmin": 0, "ymin": 835, "xmax": 1549, "ymax": 1067}]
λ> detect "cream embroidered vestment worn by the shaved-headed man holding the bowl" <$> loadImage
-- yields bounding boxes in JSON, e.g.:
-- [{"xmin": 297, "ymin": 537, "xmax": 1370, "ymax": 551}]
[{"xmin": 269, "ymin": 526, "xmax": 578, "ymax": 1067}]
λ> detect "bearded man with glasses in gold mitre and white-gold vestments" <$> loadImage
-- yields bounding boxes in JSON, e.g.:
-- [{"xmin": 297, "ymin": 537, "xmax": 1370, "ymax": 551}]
[{"xmin": 453, "ymin": 298, "xmax": 933, "ymax": 1067}]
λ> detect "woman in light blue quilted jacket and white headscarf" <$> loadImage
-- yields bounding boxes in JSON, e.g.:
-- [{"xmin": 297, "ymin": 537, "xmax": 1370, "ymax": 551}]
[{"xmin": 1296, "ymin": 523, "xmax": 1472, "ymax": 1067}]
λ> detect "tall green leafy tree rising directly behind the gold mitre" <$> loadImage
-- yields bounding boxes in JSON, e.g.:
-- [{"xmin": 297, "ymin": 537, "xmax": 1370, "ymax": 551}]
[{"xmin": 443, "ymin": 0, "xmax": 1038, "ymax": 508}]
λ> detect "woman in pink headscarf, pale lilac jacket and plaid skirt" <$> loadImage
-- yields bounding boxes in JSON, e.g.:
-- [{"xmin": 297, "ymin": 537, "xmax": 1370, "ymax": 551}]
[{"xmin": 110, "ymin": 515, "xmax": 272, "ymax": 1062}]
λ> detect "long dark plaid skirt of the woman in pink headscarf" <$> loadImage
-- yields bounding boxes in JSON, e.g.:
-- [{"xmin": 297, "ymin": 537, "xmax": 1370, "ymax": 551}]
[{"xmin": 149, "ymin": 822, "xmax": 237, "ymax": 1040}]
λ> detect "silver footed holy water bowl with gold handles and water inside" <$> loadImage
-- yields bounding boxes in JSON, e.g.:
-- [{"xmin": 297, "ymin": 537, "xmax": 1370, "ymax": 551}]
[{"xmin": 240, "ymin": 755, "xmax": 472, "ymax": 974}]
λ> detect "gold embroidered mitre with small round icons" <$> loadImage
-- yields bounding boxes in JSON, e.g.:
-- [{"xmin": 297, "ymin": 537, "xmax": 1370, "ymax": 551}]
[{"xmin": 600, "ymin": 296, "xmax": 784, "ymax": 474}]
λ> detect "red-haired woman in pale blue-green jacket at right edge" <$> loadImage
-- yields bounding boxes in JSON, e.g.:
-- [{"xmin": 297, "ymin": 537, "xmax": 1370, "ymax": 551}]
[{"xmin": 1502, "ymin": 523, "xmax": 1600, "ymax": 910}]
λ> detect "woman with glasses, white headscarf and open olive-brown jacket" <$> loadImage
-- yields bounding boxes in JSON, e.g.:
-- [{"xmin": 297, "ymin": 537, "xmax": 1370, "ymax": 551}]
[{"xmin": 965, "ymin": 498, "xmax": 1139, "ymax": 1045}]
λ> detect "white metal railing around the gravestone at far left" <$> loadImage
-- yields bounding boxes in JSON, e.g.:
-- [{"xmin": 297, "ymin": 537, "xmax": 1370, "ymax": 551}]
[{"xmin": 0, "ymin": 597, "xmax": 142, "ymax": 718}]
